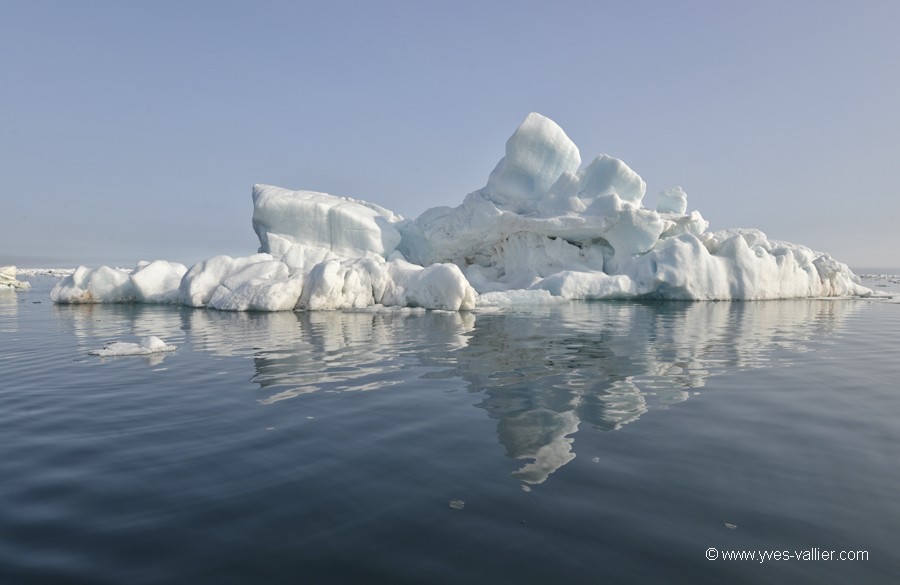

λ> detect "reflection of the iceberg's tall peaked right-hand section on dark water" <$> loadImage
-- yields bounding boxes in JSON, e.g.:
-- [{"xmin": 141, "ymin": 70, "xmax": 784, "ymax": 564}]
[{"xmin": 447, "ymin": 301, "xmax": 857, "ymax": 484}]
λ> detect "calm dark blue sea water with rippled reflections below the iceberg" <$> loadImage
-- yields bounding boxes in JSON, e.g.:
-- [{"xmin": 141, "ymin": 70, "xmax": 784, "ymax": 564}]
[{"xmin": 0, "ymin": 277, "xmax": 900, "ymax": 585}]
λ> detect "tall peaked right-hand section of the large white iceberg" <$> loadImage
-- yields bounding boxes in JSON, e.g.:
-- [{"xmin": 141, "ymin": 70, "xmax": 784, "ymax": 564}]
[{"xmin": 398, "ymin": 114, "xmax": 871, "ymax": 300}]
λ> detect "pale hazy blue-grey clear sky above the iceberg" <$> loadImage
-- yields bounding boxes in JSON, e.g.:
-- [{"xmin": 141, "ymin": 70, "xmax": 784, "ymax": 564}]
[{"xmin": 0, "ymin": 0, "xmax": 900, "ymax": 267}]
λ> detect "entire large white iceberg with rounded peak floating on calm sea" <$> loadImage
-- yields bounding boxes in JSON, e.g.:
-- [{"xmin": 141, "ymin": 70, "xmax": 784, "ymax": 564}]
[{"xmin": 51, "ymin": 113, "xmax": 873, "ymax": 311}]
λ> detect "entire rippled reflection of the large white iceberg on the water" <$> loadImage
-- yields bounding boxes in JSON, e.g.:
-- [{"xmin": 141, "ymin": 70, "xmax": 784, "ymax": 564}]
[{"xmin": 55, "ymin": 300, "xmax": 867, "ymax": 484}]
